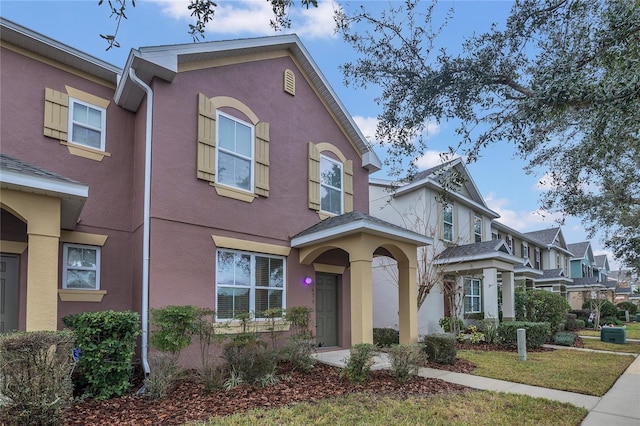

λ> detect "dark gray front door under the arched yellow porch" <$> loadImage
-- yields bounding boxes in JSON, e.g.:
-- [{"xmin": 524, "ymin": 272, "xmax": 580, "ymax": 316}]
[{"xmin": 316, "ymin": 274, "xmax": 338, "ymax": 347}]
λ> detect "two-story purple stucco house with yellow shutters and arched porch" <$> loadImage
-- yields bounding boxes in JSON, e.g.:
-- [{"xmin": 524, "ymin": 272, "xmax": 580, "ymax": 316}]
[{"xmin": 0, "ymin": 20, "xmax": 430, "ymax": 368}]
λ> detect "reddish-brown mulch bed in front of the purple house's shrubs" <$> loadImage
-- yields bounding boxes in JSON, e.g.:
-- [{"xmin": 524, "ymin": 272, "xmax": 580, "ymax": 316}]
[{"xmin": 64, "ymin": 364, "xmax": 468, "ymax": 425}]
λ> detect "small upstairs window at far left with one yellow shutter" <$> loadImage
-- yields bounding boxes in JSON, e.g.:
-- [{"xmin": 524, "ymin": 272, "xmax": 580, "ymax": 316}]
[{"xmin": 69, "ymin": 98, "xmax": 107, "ymax": 151}]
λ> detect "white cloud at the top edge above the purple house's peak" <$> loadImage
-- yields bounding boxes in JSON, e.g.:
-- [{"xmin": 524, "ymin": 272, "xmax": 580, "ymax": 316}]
[{"xmin": 151, "ymin": 0, "xmax": 335, "ymax": 38}]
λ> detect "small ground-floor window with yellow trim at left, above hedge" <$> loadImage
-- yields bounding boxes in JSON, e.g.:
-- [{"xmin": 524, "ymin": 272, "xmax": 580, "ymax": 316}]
[{"xmin": 62, "ymin": 244, "xmax": 101, "ymax": 290}]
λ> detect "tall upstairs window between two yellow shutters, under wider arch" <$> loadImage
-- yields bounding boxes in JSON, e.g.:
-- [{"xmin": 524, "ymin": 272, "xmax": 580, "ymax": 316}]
[{"xmin": 216, "ymin": 111, "xmax": 255, "ymax": 192}]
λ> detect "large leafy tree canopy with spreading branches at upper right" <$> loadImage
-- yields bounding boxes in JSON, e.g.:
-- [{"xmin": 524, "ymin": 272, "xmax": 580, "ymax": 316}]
[{"xmin": 336, "ymin": 0, "xmax": 640, "ymax": 269}]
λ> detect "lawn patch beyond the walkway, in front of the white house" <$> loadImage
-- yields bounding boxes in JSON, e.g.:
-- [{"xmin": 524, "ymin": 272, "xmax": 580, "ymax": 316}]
[{"xmin": 458, "ymin": 349, "xmax": 633, "ymax": 396}]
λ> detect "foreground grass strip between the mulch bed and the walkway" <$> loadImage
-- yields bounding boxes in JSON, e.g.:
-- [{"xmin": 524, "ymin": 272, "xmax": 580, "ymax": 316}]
[{"xmin": 200, "ymin": 391, "xmax": 587, "ymax": 426}]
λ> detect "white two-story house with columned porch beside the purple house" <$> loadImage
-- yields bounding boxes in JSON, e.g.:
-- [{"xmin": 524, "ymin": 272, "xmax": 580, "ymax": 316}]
[{"xmin": 369, "ymin": 159, "xmax": 522, "ymax": 334}]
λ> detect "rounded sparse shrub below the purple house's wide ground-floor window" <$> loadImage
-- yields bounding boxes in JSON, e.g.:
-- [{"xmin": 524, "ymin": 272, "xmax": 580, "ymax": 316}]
[{"xmin": 222, "ymin": 337, "xmax": 278, "ymax": 384}]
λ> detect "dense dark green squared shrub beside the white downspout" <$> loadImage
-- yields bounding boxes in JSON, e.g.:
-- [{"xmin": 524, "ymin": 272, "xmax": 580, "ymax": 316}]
[{"xmin": 62, "ymin": 311, "xmax": 140, "ymax": 399}]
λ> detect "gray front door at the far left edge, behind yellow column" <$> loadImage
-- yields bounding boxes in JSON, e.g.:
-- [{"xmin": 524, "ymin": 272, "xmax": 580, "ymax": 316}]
[{"xmin": 0, "ymin": 254, "xmax": 18, "ymax": 333}]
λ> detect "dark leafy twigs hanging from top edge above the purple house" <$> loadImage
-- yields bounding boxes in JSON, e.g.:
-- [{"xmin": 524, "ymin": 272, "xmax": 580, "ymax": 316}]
[{"xmin": 98, "ymin": 0, "xmax": 318, "ymax": 50}]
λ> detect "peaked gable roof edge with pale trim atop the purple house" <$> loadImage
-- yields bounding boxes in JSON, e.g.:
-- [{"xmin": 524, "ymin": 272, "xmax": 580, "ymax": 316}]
[{"xmin": 115, "ymin": 34, "xmax": 382, "ymax": 173}]
